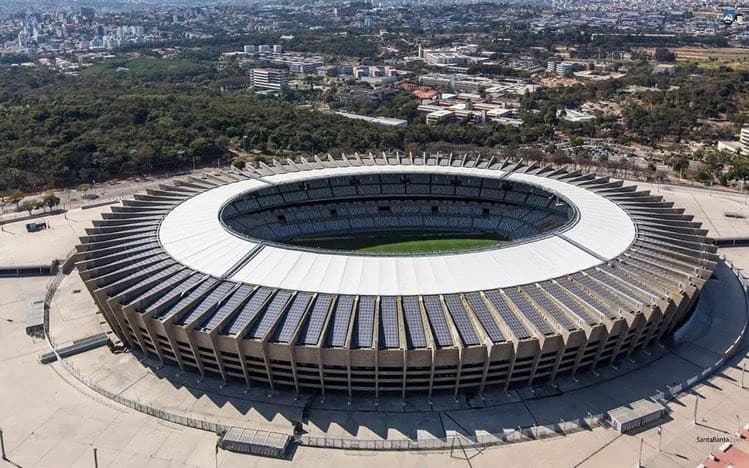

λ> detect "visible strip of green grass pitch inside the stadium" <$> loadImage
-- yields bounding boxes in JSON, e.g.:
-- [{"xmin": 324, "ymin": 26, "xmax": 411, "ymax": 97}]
[{"xmin": 293, "ymin": 233, "xmax": 507, "ymax": 254}]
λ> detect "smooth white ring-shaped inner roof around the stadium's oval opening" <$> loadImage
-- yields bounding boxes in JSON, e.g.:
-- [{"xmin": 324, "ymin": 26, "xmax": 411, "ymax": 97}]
[{"xmin": 159, "ymin": 166, "xmax": 635, "ymax": 295}]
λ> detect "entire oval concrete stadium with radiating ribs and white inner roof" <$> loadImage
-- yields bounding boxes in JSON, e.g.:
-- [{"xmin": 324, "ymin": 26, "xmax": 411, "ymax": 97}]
[{"xmin": 76, "ymin": 154, "xmax": 717, "ymax": 398}]
